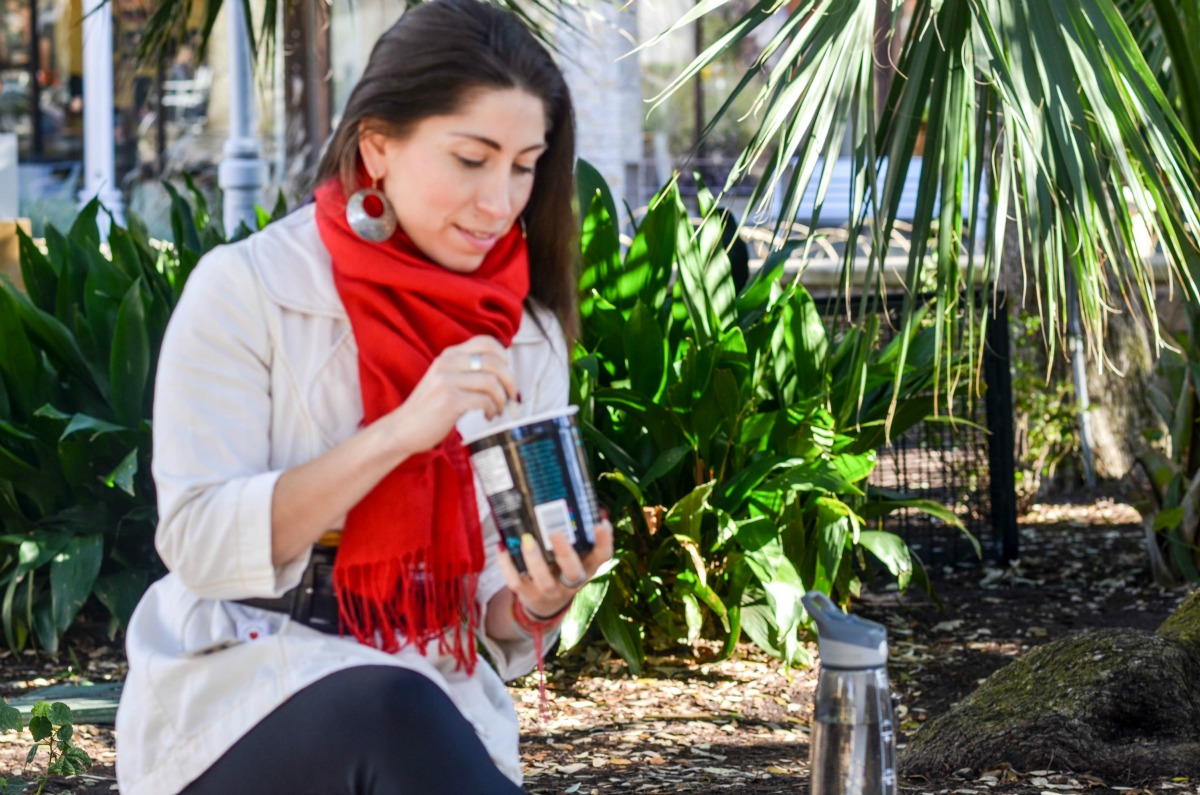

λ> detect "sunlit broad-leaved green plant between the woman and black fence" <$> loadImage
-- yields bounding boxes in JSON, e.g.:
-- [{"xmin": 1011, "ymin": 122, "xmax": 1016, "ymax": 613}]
[{"xmin": 563, "ymin": 163, "xmax": 961, "ymax": 673}]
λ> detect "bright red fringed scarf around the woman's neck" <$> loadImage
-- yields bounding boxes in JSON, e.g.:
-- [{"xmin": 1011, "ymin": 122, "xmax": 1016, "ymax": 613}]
[{"xmin": 316, "ymin": 178, "xmax": 529, "ymax": 671}]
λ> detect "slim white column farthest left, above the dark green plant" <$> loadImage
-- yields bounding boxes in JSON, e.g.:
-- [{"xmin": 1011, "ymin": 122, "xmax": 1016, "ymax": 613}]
[{"xmin": 79, "ymin": 0, "xmax": 125, "ymax": 230}]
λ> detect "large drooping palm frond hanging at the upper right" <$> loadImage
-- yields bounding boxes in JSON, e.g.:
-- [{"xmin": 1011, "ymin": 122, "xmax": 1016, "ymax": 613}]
[{"xmin": 652, "ymin": 0, "xmax": 1200, "ymax": 408}]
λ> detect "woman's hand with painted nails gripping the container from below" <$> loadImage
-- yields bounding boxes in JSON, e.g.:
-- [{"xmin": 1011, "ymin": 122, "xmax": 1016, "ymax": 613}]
[{"xmin": 498, "ymin": 520, "xmax": 612, "ymax": 616}]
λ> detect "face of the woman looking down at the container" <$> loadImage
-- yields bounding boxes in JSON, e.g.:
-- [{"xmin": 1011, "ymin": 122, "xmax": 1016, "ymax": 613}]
[{"xmin": 359, "ymin": 89, "xmax": 546, "ymax": 273}]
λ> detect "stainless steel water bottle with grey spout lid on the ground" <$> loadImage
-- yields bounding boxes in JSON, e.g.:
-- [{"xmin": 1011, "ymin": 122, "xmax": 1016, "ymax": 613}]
[{"xmin": 803, "ymin": 592, "xmax": 896, "ymax": 795}]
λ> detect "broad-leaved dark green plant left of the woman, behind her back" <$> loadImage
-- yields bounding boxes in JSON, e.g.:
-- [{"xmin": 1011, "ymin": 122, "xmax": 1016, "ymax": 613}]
[{"xmin": 0, "ymin": 184, "xmax": 281, "ymax": 652}]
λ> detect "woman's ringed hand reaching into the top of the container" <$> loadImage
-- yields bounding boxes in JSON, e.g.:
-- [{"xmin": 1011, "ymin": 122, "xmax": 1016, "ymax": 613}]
[{"xmin": 385, "ymin": 336, "xmax": 518, "ymax": 455}]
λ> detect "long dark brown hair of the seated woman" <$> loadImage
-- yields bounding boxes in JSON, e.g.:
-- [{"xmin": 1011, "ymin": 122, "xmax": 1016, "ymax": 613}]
[{"xmin": 317, "ymin": 0, "xmax": 580, "ymax": 341}]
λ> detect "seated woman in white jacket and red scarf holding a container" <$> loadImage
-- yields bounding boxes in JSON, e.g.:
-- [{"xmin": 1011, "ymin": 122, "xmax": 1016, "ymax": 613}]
[{"xmin": 118, "ymin": 0, "xmax": 612, "ymax": 795}]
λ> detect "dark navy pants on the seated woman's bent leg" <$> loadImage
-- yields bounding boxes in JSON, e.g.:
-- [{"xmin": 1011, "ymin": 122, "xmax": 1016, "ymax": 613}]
[{"xmin": 182, "ymin": 665, "xmax": 523, "ymax": 795}]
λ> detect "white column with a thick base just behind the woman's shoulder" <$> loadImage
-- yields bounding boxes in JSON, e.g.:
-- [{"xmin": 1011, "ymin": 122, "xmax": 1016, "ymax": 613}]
[{"xmin": 217, "ymin": 0, "xmax": 268, "ymax": 234}]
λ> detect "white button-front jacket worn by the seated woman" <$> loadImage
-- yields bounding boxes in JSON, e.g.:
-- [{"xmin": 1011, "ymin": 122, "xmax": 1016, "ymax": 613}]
[{"xmin": 116, "ymin": 207, "xmax": 569, "ymax": 795}]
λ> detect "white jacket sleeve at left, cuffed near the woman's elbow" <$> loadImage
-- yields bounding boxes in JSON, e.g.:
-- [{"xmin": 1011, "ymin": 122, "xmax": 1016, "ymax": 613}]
[{"xmin": 152, "ymin": 246, "xmax": 307, "ymax": 599}]
